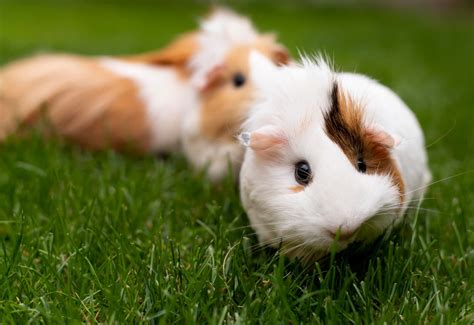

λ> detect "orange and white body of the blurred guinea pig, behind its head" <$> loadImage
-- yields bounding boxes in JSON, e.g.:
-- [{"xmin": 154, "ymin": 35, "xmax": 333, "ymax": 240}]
[{"xmin": 0, "ymin": 54, "xmax": 195, "ymax": 152}]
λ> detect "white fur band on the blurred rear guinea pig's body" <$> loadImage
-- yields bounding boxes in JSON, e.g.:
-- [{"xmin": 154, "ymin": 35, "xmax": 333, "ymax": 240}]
[{"xmin": 101, "ymin": 58, "xmax": 198, "ymax": 151}]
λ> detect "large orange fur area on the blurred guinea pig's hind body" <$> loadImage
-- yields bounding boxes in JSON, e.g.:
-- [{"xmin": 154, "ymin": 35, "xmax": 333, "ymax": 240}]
[{"xmin": 0, "ymin": 55, "xmax": 150, "ymax": 152}]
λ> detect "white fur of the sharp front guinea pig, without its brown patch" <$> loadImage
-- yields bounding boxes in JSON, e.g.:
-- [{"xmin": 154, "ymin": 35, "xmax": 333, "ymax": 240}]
[{"xmin": 240, "ymin": 53, "xmax": 430, "ymax": 259}]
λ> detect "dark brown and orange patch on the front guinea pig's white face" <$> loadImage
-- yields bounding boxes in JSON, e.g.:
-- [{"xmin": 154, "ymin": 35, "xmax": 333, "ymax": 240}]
[{"xmin": 325, "ymin": 83, "xmax": 405, "ymax": 201}]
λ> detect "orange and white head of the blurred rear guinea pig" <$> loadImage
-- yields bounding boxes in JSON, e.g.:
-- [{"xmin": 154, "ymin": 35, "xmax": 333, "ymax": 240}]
[{"xmin": 184, "ymin": 9, "xmax": 289, "ymax": 179}]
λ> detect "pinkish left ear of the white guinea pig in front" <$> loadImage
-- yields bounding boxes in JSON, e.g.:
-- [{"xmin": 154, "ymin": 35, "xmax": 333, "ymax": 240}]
[{"xmin": 238, "ymin": 125, "xmax": 288, "ymax": 160}]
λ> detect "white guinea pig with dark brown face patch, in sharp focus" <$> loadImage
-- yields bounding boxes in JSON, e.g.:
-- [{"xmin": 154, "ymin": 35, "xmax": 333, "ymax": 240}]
[{"xmin": 239, "ymin": 53, "xmax": 431, "ymax": 262}]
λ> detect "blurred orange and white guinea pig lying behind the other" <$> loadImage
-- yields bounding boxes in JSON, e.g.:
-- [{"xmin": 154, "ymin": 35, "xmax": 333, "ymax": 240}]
[{"xmin": 0, "ymin": 9, "xmax": 288, "ymax": 180}]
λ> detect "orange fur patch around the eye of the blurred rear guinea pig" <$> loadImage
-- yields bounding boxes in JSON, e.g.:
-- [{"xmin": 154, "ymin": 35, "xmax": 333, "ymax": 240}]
[{"xmin": 201, "ymin": 38, "xmax": 288, "ymax": 142}]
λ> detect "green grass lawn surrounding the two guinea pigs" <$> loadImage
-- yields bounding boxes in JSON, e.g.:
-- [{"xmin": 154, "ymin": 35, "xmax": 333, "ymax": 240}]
[{"xmin": 0, "ymin": 1, "xmax": 474, "ymax": 324}]
